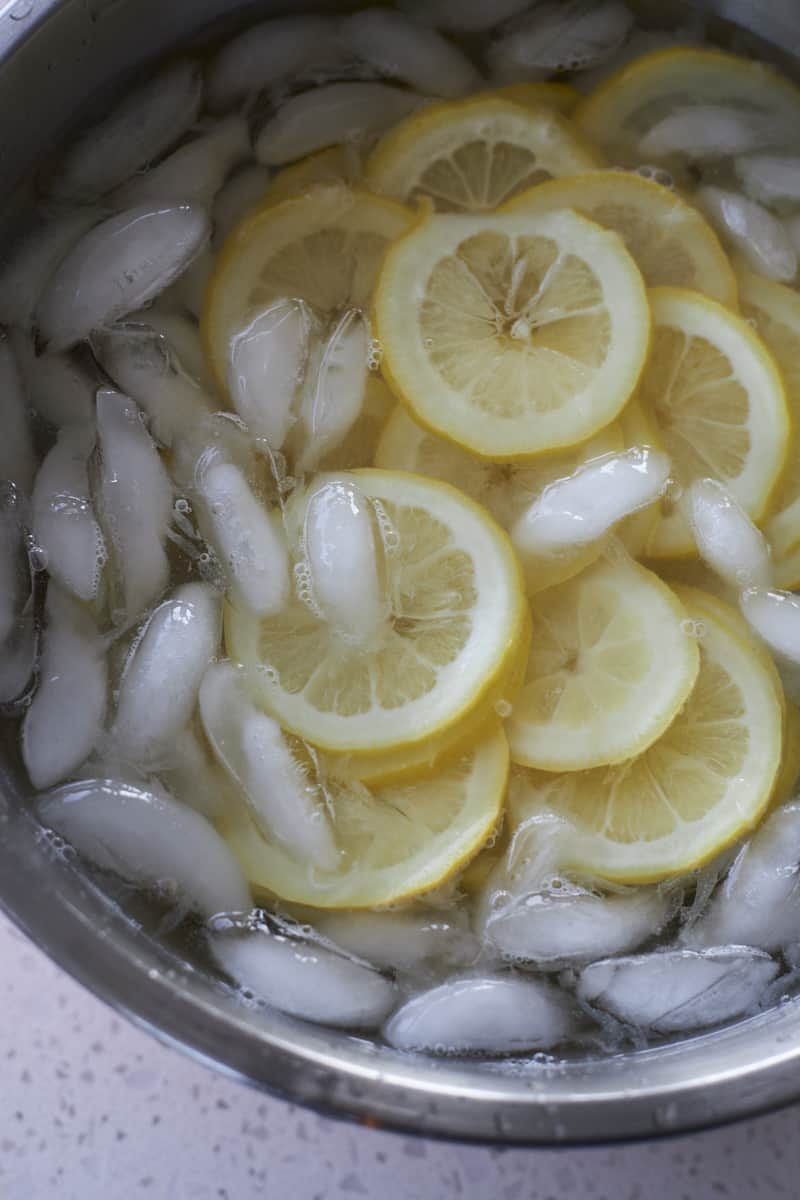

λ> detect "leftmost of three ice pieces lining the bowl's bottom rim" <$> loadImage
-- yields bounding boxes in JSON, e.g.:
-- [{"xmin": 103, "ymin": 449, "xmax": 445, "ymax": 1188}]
[{"xmin": 209, "ymin": 929, "xmax": 396, "ymax": 1030}]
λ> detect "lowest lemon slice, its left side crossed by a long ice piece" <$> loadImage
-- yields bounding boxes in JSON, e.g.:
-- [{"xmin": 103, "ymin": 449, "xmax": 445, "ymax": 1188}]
[{"xmin": 219, "ymin": 724, "xmax": 509, "ymax": 908}]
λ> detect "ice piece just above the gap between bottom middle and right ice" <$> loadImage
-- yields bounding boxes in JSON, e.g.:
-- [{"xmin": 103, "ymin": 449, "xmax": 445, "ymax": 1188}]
[{"xmin": 483, "ymin": 876, "xmax": 674, "ymax": 971}]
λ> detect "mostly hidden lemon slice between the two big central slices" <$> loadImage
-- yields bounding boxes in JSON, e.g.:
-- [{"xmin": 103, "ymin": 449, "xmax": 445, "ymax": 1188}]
[{"xmin": 375, "ymin": 404, "xmax": 625, "ymax": 595}]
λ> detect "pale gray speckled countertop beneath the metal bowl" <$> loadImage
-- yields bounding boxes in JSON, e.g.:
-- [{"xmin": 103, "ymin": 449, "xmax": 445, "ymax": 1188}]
[{"xmin": 0, "ymin": 918, "xmax": 800, "ymax": 1200}]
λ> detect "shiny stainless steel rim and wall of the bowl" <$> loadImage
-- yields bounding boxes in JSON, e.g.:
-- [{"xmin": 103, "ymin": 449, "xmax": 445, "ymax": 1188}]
[{"xmin": 0, "ymin": 0, "xmax": 800, "ymax": 1145}]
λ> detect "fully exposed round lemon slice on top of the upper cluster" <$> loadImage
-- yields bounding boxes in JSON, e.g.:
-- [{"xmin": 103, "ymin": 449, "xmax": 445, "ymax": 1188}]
[{"xmin": 374, "ymin": 211, "xmax": 650, "ymax": 460}]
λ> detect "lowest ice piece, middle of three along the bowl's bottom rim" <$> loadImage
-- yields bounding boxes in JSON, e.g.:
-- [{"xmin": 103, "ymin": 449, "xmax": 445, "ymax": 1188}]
[{"xmin": 384, "ymin": 976, "xmax": 575, "ymax": 1055}]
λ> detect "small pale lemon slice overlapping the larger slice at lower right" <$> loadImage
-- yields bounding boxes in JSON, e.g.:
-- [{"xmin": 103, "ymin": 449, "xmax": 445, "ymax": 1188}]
[{"xmin": 506, "ymin": 549, "xmax": 699, "ymax": 770}]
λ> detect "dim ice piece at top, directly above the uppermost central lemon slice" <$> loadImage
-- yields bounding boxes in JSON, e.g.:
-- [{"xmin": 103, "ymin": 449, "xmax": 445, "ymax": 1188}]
[{"xmin": 339, "ymin": 8, "xmax": 480, "ymax": 100}]
